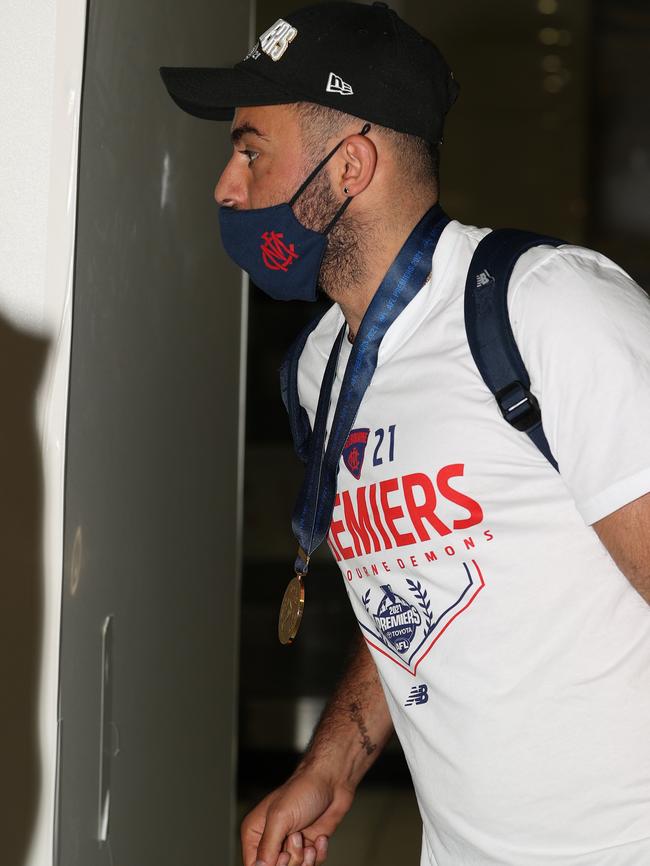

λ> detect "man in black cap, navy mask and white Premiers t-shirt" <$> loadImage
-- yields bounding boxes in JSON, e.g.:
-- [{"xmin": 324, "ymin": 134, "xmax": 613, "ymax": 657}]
[{"xmin": 162, "ymin": 3, "xmax": 650, "ymax": 866}]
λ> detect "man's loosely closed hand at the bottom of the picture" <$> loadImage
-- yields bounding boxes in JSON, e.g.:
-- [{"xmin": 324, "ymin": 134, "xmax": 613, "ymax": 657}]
[{"xmin": 241, "ymin": 768, "xmax": 354, "ymax": 866}]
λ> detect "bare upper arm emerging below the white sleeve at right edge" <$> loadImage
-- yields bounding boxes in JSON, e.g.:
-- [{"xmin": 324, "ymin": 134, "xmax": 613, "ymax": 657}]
[{"xmin": 593, "ymin": 493, "xmax": 650, "ymax": 604}]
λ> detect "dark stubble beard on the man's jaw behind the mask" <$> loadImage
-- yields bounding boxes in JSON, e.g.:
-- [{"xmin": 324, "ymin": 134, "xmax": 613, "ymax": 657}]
[{"xmin": 293, "ymin": 173, "xmax": 368, "ymax": 301}]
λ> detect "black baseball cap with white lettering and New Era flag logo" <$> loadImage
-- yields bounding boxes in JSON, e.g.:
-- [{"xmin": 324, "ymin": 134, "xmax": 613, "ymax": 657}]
[{"xmin": 160, "ymin": 3, "xmax": 458, "ymax": 144}]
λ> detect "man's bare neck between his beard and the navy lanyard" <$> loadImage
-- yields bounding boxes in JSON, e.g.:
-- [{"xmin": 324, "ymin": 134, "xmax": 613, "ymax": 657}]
[{"xmin": 328, "ymin": 201, "xmax": 435, "ymax": 341}]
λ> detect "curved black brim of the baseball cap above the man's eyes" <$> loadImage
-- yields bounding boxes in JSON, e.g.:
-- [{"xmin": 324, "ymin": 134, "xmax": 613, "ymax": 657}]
[{"xmin": 160, "ymin": 66, "xmax": 299, "ymax": 120}]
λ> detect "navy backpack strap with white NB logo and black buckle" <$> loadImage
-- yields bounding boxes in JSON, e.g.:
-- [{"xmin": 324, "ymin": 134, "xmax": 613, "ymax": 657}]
[{"xmin": 465, "ymin": 229, "xmax": 564, "ymax": 469}]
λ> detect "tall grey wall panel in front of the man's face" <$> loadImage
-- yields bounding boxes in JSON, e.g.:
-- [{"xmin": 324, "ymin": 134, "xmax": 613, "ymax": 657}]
[{"xmin": 57, "ymin": 0, "xmax": 249, "ymax": 866}]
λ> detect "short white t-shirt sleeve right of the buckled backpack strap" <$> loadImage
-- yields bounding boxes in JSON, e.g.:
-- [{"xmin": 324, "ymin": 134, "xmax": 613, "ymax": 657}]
[{"xmin": 509, "ymin": 245, "xmax": 650, "ymax": 524}]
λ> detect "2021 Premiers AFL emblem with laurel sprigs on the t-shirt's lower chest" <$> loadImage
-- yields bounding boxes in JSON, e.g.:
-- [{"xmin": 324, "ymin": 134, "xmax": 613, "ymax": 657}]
[{"xmin": 353, "ymin": 560, "xmax": 485, "ymax": 676}]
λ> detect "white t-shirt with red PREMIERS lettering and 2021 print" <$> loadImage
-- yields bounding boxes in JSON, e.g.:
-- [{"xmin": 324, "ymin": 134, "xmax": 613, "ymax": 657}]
[{"xmin": 299, "ymin": 222, "xmax": 650, "ymax": 866}]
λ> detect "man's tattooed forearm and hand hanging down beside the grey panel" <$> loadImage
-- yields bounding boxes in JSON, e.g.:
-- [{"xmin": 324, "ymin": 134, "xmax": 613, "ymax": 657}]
[{"xmin": 241, "ymin": 639, "xmax": 393, "ymax": 866}]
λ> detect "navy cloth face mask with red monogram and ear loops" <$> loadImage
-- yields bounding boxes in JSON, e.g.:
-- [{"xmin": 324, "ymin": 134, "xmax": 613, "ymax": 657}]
[{"xmin": 219, "ymin": 123, "xmax": 370, "ymax": 301}]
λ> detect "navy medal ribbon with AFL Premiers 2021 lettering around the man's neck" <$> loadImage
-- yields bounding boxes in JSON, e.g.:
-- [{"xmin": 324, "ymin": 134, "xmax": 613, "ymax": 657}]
[{"xmin": 291, "ymin": 204, "xmax": 449, "ymax": 575}]
